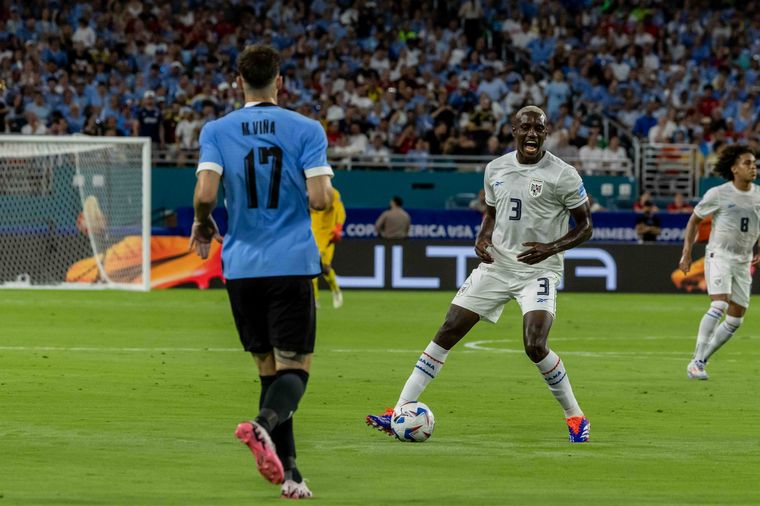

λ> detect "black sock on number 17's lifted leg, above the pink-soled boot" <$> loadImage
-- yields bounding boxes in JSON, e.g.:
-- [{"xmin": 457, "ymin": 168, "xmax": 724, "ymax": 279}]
[{"xmin": 256, "ymin": 369, "xmax": 309, "ymax": 433}]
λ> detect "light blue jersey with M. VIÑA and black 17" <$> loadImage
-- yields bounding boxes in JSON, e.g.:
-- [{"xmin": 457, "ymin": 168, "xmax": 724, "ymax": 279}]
[{"xmin": 197, "ymin": 102, "xmax": 333, "ymax": 279}]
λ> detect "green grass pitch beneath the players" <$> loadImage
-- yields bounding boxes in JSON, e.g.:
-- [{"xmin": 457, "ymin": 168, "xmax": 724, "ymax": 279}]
[{"xmin": 0, "ymin": 290, "xmax": 760, "ymax": 506}]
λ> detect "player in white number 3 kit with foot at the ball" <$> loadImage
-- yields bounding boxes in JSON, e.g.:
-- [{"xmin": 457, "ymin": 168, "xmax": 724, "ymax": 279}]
[{"xmin": 366, "ymin": 106, "xmax": 591, "ymax": 443}]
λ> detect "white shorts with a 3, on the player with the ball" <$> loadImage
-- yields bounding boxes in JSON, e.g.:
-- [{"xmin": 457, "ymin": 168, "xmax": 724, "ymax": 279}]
[{"xmin": 451, "ymin": 263, "xmax": 560, "ymax": 323}]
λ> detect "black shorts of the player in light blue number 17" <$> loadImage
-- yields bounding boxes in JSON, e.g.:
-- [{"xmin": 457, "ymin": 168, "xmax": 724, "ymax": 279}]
[{"xmin": 227, "ymin": 276, "xmax": 317, "ymax": 353}]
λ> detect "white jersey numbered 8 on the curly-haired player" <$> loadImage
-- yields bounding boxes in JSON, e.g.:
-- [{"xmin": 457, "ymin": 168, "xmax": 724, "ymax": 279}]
[{"xmin": 694, "ymin": 181, "xmax": 760, "ymax": 262}]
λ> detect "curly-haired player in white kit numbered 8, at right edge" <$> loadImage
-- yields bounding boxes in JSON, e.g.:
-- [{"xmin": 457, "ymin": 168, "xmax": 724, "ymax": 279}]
[{"xmin": 678, "ymin": 145, "xmax": 760, "ymax": 380}]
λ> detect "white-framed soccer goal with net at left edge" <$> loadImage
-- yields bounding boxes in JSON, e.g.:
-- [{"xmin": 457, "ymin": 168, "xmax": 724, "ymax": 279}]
[{"xmin": 0, "ymin": 135, "xmax": 151, "ymax": 290}]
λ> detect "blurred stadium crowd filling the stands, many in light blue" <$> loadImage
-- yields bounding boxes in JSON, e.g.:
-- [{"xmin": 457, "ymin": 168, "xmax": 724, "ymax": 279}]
[{"xmin": 0, "ymin": 0, "xmax": 760, "ymax": 169}]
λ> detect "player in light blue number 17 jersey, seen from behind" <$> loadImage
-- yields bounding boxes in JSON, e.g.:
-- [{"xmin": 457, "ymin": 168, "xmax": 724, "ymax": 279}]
[{"xmin": 190, "ymin": 45, "xmax": 333, "ymax": 499}]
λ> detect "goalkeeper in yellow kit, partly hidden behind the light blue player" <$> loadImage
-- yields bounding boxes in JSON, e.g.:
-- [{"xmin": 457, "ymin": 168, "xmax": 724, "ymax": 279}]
[{"xmin": 311, "ymin": 185, "xmax": 346, "ymax": 309}]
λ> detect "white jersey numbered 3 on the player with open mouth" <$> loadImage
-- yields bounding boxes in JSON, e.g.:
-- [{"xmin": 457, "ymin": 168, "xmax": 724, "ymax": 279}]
[{"xmin": 484, "ymin": 151, "xmax": 588, "ymax": 274}]
